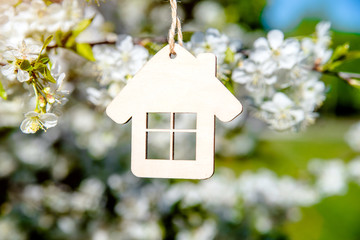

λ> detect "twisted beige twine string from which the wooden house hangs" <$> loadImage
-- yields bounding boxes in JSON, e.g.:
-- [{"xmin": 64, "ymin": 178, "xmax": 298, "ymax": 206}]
[{"xmin": 168, "ymin": 0, "xmax": 183, "ymax": 55}]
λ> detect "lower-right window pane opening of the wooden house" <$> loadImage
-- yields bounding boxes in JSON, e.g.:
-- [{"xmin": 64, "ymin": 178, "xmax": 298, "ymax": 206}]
[{"xmin": 174, "ymin": 132, "xmax": 196, "ymax": 160}]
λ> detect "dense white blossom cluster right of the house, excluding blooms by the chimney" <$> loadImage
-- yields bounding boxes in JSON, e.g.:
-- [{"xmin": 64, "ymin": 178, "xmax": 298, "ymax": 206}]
[{"xmin": 232, "ymin": 22, "xmax": 332, "ymax": 131}]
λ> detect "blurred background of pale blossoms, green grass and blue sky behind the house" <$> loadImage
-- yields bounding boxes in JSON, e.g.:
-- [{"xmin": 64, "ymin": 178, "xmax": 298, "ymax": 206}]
[{"xmin": 0, "ymin": 0, "xmax": 360, "ymax": 240}]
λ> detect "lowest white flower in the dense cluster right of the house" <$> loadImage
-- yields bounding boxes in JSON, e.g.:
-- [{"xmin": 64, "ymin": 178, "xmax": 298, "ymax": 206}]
[{"xmin": 261, "ymin": 92, "xmax": 304, "ymax": 131}]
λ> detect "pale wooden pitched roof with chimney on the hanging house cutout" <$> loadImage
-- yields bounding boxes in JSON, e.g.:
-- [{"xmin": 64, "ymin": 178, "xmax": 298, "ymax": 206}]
[{"xmin": 106, "ymin": 45, "xmax": 242, "ymax": 123}]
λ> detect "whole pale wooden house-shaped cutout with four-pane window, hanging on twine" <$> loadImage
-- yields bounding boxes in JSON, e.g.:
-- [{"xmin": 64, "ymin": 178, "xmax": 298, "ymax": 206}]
[{"xmin": 106, "ymin": 45, "xmax": 242, "ymax": 179}]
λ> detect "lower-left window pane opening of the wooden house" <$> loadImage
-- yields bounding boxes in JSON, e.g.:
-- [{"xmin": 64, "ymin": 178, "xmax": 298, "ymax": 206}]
[{"xmin": 146, "ymin": 132, "xmax": 170, "ymax": 159}]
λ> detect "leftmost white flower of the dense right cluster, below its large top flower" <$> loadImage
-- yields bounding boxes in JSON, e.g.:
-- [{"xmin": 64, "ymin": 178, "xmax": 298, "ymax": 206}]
[{"xmin": 232, "ymin": 59, "xmax": 276, "ymax": 92}]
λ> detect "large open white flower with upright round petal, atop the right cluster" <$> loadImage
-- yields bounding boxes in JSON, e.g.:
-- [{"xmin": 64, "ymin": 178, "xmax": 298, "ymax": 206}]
[{"xmin": 250, "ymin": 30, "xmax": 300, "ymax": 69}]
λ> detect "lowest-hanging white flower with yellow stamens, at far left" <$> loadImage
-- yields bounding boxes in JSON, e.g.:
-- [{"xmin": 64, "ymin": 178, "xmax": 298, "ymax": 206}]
[{"xmin": 20, "ymin": 111, "xmax": 58, "ymax": 133}]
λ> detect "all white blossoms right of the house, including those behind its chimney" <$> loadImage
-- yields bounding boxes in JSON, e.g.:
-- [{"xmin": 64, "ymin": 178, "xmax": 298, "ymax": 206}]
[{"xmin": 186, "ymin": 22, "xmax": 332, "ymax": 131}]
